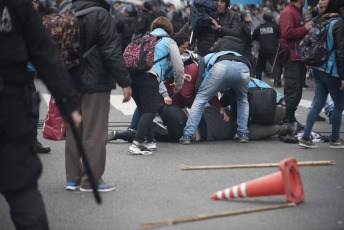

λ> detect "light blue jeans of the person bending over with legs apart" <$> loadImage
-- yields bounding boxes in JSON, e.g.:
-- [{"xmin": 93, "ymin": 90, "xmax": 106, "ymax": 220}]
[{"xmin": 184, "ymin": 60, "xmax": 250, "ymax": 137}]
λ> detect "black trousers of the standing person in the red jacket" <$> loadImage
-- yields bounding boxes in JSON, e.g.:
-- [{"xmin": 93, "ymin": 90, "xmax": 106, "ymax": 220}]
[{"xmin": 282, "ymin": 52, "xmax": 306, "ymax": 123}]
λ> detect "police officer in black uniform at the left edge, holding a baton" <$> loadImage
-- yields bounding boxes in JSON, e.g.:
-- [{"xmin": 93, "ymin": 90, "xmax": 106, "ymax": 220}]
[{"xmin": 0, "ymin": 0, "xmax": 81, "ymax": 229}]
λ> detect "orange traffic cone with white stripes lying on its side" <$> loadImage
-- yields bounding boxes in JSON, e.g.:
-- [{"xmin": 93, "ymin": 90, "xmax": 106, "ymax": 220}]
[{"xmin": 211, "ymin": 158, "xmax": 305, "ymax": 203}]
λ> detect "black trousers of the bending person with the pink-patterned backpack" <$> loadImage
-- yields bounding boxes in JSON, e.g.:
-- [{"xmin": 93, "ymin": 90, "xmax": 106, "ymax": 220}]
[{"xmin": 131, "ymin": 73, "xmax": 161, "ymax": 143}]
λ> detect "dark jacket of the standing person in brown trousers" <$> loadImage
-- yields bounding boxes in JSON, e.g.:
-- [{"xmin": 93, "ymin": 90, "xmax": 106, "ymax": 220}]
[{"xmin": 70, "ymin": 0, "xmax": 131, "ymax": 93}]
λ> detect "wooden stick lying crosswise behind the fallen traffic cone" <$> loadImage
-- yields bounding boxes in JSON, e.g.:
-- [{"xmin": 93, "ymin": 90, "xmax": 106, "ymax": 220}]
[{"xmin": 179, "ymin": 160, "xmax": 336, "ymax": 170}]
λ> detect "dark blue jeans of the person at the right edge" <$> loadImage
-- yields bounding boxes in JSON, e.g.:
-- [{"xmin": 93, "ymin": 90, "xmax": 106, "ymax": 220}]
[{"xmin": 303, "ymin": 69, "xmax": 344, "ymax": 141}]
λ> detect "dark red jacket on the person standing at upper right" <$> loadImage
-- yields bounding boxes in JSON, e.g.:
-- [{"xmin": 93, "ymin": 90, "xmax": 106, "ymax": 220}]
[{"xmin": 279, "ymin": 2, "xmax": 308, "ymax": 61}]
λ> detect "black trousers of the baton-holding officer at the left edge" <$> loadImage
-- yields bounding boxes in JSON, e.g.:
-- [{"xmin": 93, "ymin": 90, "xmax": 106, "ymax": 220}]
[{"xmin": 0, "ymin": 86, "xmax": 49, "ymax": 229}]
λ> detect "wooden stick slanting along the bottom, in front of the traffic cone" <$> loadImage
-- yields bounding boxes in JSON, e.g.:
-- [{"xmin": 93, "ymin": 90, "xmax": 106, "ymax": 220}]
[{"xmin": 141, "ymin": 203, "xmax": 296, "ymax": 229}]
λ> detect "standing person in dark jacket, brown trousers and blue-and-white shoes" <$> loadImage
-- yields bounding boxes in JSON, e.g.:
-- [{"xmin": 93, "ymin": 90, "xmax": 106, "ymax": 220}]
[{"xmin": 65, "ymin": 0, "xmax": 131, "ymax": 192}]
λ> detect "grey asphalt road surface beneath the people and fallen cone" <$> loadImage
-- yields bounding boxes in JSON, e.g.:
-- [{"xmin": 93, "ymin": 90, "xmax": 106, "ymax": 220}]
[{"xmin": 0, "ymin": 79, "xmax": 344, "ymax": 230}]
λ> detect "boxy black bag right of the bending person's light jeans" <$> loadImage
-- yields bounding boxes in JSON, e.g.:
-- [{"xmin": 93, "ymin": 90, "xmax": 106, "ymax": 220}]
[{"xmin": 248, "ymin": 81, "xmax": 276, "ymax": 124}]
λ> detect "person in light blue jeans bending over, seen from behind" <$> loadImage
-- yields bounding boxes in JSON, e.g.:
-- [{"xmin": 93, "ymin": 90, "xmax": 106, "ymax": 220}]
[{"xmin": 179, "ymin": 37, "xmax": 250, "ymax": 144}]
